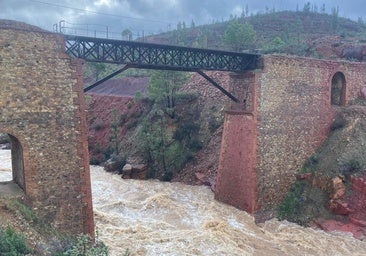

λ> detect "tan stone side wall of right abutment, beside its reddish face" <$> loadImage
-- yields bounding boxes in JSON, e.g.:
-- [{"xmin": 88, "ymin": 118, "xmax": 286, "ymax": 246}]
[{"xmin": 256, "ymin": 56, "xmax": 366, "ymax": 213}]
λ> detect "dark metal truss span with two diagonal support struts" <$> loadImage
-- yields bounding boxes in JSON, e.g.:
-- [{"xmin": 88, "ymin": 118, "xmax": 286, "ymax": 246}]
[{"xmin": 64, "ymin": 35, "xmax": 259, "ymax": 102}]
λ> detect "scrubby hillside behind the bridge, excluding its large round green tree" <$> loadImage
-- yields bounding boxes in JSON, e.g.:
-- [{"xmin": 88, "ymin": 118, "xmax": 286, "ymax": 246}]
[{"xmin": 144, "ymin": 11, "xmax": 366, "ymax": 58}]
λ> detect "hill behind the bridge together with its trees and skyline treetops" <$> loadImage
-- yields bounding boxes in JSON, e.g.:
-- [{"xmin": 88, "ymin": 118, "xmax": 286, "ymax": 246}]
[{"xmin": 146, "ymin": 2, "xmax": 366, "ymax": 57}]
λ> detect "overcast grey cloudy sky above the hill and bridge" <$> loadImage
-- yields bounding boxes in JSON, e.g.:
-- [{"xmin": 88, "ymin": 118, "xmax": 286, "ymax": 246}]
[{"xmin": 0, "ymin": 0, "xmax": 366, "ymax": 36}]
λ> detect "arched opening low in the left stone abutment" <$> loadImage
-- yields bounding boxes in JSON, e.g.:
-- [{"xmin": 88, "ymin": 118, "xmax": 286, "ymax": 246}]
[{"xmin": 0, "ymin": 133, "xmax": 25, "ymax": 190}]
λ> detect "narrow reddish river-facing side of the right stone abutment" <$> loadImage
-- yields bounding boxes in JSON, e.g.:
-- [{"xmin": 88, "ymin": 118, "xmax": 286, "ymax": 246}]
[{"xmin": 215, "ymin": 71, "xmax": 258, "ymax": 213}]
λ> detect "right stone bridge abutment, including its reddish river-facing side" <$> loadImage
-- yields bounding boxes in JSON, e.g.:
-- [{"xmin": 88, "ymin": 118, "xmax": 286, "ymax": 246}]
[{"xmin": 215, "ymin": 55, "xmax": 366, "ymax": 217}]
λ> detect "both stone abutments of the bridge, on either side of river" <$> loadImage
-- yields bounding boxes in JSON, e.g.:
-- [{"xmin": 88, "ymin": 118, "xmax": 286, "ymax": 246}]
[{"xmin": 0, "ymin": 21, "xmax": 366, "ymax": 235}]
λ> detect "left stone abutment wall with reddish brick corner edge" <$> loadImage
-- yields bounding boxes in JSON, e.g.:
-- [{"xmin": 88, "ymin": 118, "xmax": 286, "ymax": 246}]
[{"xmin": 0, "ymin": 20, "xmax": 94, "ymax": 235}]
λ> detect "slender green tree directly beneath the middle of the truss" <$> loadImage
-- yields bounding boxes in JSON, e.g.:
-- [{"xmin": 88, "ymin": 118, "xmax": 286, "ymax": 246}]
[{"xmin": 147, "ymin": 71, "xmax": 188, "ymax": 118}]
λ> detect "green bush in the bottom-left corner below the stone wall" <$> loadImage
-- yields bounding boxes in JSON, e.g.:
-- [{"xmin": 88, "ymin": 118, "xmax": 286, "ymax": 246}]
[{"xmin": 0, "ymin": 228, "xmax": 31, "ymax": 256}]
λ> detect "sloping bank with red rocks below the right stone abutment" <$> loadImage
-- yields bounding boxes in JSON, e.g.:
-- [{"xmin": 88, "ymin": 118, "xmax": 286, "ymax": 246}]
[{"xmin": 279, "ymin": 100, "xmax": 366, "ymax": 239}]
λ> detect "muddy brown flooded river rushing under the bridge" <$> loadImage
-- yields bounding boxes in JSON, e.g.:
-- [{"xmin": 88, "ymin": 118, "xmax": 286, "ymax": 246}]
[{"xmin": 0, "ymin": 150, "xmax": 366, "ymax": 256}]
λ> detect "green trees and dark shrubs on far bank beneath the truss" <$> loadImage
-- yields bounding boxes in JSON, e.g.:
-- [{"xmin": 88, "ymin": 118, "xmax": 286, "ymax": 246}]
[{"xmin": 134, "ymin": 71, "xmax": 202, "ymax": 181}]
